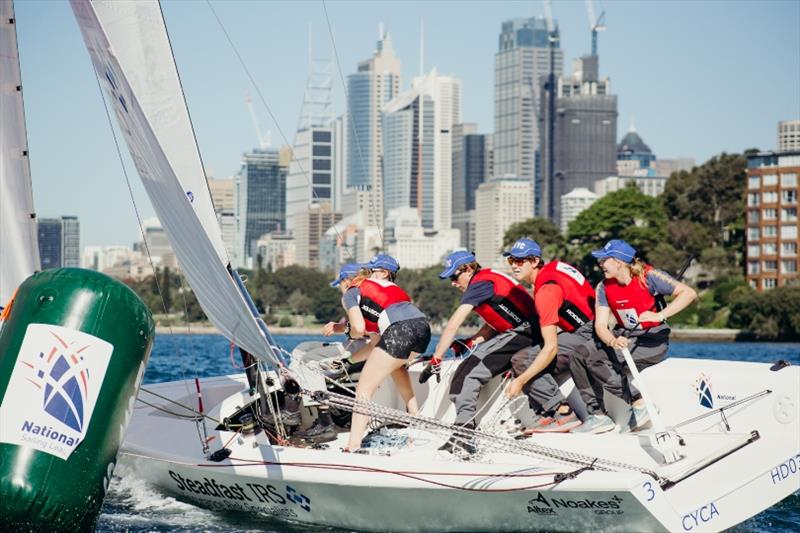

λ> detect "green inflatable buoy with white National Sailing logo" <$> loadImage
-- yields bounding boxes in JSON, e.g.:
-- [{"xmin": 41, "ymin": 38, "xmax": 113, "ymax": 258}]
[{"xmin": 0, "ymin": 268, "xmax": 155, "ymax": 531}]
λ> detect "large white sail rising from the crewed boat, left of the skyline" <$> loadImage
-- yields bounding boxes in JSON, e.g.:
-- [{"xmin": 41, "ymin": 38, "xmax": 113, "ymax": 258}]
[{"xmin": 70, "ymin": 0, "xmax": 278, "ymax": 363}]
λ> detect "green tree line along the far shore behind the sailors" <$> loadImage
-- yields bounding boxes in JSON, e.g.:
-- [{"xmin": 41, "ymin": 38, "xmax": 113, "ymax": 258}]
[{"xmin": 129, "ymin": 153, "xmax": 800, "ymax": 340}]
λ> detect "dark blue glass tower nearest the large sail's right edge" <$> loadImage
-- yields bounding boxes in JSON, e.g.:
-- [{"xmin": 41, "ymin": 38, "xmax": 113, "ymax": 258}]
[{"xmin": 235, "ymin": 149, "xmax": 287, "ymax": 266}]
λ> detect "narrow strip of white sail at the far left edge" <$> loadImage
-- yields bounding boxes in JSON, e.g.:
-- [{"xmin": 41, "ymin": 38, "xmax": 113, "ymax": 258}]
[{"xmin": 0, "ymin": 0, "xmax": 41, "ymax": 306}]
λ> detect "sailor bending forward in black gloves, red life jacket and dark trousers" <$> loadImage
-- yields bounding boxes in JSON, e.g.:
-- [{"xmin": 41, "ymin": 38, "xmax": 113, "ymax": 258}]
[{"xmin": 419, "ymin": 250, "xmax": 539, "ymax": 453}]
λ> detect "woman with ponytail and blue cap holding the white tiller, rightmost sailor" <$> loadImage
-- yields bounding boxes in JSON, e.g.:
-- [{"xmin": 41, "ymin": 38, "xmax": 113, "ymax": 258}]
[{"xmin": 570, "ymin": 239, "xmax": 697, "ymax": 433}]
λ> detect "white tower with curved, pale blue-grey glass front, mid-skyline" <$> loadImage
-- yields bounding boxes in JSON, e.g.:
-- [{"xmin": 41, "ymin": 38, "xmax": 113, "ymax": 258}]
[{"xmin": 383, "ymin": 69, "xmax": 461, "ymax": 230}]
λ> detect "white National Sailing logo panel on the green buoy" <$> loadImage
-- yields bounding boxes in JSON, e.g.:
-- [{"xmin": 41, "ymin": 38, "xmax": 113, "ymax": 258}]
[{"xmin": 0, "ymin": 324, "xmax": 114, "ymax": 459}]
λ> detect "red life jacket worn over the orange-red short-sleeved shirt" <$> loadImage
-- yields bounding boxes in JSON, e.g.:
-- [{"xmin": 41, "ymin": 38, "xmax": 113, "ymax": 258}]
[{"xmin": 533, "ymin": 261, "xmax": 595, "ymax": 331}]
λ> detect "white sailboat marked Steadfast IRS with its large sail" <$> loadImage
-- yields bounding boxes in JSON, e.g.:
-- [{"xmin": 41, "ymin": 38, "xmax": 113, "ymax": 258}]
[{"xmin": 71, "ymin": 0, "xmax": 800, "ymax": 531}]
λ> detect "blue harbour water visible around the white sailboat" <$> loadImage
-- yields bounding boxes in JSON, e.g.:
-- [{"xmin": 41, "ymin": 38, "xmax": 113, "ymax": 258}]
[{"xmin": 97, "ymin": 335, "xmax": 800, "ymax": 533}]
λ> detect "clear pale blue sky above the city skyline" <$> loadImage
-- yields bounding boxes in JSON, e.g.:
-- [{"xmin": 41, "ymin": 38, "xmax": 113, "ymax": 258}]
[{"xmin": 16, "ymin": 0, "xmax": 800, "ymax": 246}]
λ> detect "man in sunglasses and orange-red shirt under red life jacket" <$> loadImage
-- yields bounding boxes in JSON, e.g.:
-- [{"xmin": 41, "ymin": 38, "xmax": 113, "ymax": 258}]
[{"xmin": 503, "ymin": 239, "xmax": 594, "ymax": 432}]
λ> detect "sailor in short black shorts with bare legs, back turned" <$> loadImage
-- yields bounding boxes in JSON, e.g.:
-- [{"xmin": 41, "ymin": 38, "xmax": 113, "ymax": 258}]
[{"xmin": 342, "ymin": 254, "xmax": 431, "ymax": 451}]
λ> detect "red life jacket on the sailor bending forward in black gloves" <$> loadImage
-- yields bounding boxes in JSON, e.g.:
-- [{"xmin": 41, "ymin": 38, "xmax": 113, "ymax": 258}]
[{"xmin": 470, "ymin": 268, "xmax": 535, "ymax": 333}]
